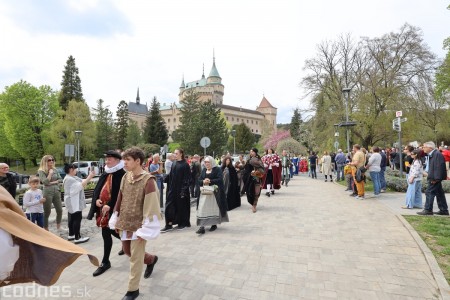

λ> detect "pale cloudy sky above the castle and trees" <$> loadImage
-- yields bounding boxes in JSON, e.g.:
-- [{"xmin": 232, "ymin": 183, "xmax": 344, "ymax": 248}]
[{"xmin": 0, "ymin": 0, "xmax": 450, "ymax": 123}]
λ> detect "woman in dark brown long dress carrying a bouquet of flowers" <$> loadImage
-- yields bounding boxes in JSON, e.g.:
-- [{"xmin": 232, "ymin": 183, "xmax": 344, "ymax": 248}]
[{"xmin": 243, "ymin": 148, "xmax": 264, "ymax": 213}]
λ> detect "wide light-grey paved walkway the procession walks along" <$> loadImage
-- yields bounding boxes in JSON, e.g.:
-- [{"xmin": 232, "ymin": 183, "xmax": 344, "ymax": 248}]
[{"xmin": 3, "ymin": 176, "xmax": 450, "ymax": 300}]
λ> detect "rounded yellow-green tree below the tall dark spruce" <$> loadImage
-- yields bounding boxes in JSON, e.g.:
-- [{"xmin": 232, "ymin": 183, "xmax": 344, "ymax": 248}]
[{"xmin": 46, "ymin": 100, "xmax": 97, "ymax": 161}]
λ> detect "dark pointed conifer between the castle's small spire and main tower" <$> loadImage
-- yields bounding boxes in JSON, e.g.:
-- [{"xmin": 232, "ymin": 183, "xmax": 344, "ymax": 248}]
[{"xmin": 144, "ymin": 97, "xmax": 169, "ymax": 146}]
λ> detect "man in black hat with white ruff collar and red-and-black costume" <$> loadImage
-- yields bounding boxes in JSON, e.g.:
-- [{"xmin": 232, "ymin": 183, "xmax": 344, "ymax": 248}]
[{"xmin": 87, "ymin": 150, "xmax": 125, "ymax": 276}]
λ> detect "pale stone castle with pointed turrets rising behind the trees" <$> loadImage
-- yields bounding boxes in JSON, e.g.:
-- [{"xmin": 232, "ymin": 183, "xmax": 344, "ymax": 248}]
[{"xmin": 128, "ymin": 57, "xmax": 277, "ymax": 140}]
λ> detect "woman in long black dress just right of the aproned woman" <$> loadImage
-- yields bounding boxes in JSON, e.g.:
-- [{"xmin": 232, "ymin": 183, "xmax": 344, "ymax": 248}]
[{"xmin": 222, "ymin": 156, "xmax": 241, "ymax": 211}]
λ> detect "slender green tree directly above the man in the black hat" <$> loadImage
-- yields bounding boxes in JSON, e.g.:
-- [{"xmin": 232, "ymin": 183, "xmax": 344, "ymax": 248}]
[{"xmin": 93, "ymin": 99, "xmax": 116, "ymax": 157}]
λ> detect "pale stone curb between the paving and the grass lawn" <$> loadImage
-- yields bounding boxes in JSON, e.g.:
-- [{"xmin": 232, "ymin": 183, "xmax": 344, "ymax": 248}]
[{"xmin": 396, "ymin": 215, "xmax": 450, "ymax": 300}]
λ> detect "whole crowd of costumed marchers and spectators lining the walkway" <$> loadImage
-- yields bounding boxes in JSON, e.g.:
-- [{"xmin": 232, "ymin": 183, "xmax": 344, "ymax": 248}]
[{"xmin": 0, "ymin": 142, "xmax": 450, "ymax": 299}]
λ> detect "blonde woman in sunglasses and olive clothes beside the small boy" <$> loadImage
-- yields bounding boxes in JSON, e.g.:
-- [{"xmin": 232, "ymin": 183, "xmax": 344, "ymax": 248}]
[{"xmin": 38, "ymin": 155, "xmax": 62, "ymax": 230}]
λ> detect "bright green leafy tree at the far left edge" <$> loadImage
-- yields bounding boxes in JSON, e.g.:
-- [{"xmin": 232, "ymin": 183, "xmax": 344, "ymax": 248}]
[{"xmin": 0, "ymin": 81, "xmax": 58, "ymax": 166}]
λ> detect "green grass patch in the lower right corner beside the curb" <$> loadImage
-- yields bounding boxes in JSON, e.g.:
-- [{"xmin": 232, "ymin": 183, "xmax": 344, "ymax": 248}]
[{"xmin": 403, "ymin": 216, "xmax": 450, "ymax": 284}]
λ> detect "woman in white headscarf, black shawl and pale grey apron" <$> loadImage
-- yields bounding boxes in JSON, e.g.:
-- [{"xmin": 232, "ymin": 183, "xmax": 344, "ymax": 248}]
[{"xmin": 196, "ymin": 156, "xmax": 229, "ymax": 234}]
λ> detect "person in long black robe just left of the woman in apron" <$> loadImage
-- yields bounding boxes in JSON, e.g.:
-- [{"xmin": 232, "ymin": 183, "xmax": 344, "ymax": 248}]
[{"xmin": 161, "ymin": 149, "xmax": 191, "ymax": 233}]
